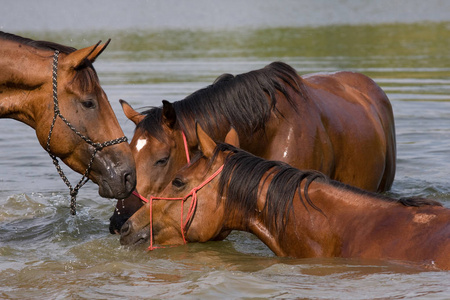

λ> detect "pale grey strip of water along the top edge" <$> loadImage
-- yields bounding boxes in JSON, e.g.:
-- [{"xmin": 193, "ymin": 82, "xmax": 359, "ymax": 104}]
[{"xmin": 0, "ymin": 0, "xmax": 450, "ymax": 31}]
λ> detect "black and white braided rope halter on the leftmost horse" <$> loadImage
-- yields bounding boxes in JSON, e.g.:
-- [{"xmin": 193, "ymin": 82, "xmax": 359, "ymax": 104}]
[{"xmin": 46, "ymin": 50, "xmax": 128, "ymax": 215}]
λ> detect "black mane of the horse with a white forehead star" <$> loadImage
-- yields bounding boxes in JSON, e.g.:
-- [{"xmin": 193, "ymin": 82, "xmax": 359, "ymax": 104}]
[{"xmin": 136, "ymin": 62, "xmax": 307, "ymax": 137}]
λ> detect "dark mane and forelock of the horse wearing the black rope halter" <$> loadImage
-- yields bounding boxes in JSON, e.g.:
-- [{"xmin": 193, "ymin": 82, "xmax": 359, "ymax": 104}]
[{"xmin": 0, "ymin": 31, "xmax": 98, "ymax": 91}]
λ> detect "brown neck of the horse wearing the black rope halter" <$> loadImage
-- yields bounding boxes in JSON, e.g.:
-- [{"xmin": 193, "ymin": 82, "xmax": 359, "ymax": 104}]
[{"xmin": 0, "ymin": 41, "xmax": 51, "ymax": 128}]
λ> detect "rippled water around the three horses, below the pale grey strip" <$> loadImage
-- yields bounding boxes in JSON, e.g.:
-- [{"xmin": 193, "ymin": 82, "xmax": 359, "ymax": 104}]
[{"xmin": 0, "ymin": 1, "xmax": 450, "ymax": 299}]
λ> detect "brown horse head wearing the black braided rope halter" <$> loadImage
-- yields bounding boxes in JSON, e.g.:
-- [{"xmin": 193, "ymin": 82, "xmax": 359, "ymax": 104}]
[{"xmin": 35, "ymin": 41, "xmax": 136, "ymax": 198}]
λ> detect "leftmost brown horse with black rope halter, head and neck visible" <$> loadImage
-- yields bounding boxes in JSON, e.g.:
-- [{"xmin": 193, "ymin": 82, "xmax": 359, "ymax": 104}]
[{"xmin": 0, "ymin": 32, "xmax": 136, "ymax": 212}]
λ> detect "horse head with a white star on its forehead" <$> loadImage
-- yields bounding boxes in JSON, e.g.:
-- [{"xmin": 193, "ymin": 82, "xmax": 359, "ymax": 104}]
[{"xmin": 110, "ymin": 100, "xmax": 193, "ymax": 234}]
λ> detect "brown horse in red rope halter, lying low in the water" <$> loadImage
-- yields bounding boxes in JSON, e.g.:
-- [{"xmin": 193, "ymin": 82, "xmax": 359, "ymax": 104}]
[{"xmin": 120, "ymin": 128, "xmax": 450, "ymax": 270}]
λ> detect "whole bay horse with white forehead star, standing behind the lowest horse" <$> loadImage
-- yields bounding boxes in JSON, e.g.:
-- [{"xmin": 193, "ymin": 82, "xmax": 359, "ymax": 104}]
[{"xmin": 110, "ymin": 62, "xmax": 396, "ymax": 233}]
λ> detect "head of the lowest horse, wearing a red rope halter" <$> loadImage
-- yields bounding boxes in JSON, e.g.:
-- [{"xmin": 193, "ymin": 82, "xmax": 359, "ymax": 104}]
[{"xmin": 120, "ymin": 125, "xmax": 239, "ymax": 249}]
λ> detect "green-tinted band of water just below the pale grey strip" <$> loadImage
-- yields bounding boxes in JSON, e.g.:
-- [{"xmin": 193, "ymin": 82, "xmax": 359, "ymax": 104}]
[{"xmin": 23, "ymin": 22, "xmax": 450, "ymax": 61}]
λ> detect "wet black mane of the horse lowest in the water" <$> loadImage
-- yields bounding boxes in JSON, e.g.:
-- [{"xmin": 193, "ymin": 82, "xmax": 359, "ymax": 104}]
[{"xmin": 210, "ymin": 144, "xmax": 442, "ymax": 234}]
